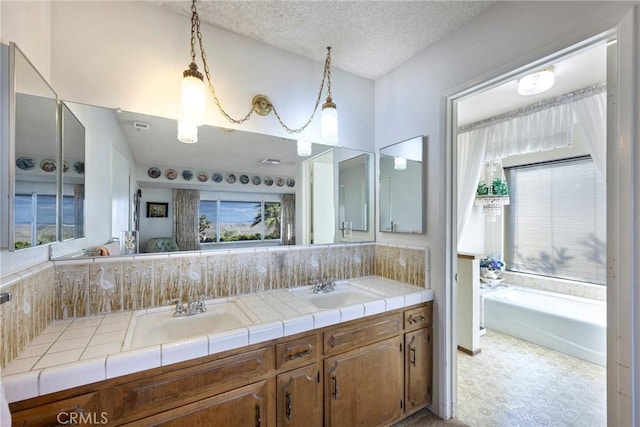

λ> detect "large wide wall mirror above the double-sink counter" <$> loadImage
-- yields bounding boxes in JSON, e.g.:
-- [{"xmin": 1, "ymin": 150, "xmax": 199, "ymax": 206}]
[{"xmin": 48, "ymin": 103, "xmax": 375, "ymax": 255}]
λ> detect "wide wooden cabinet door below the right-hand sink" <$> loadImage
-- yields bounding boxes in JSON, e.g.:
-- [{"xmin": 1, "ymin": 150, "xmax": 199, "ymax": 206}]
[{"xmin": 324, "ymin": 337, "xmax": 404, "ymax": 427}]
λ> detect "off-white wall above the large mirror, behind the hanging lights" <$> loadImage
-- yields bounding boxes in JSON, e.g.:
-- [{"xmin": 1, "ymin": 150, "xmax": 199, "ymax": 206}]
[{"xmin": 52, "ymin": 1, "xmax": 373, "ymax": 151}]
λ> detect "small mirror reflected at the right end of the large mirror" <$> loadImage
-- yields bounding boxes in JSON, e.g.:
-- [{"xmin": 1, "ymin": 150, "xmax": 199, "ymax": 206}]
[{"xmin": 338, "ymin": 154, "xmax": 369, "ymax": 235}]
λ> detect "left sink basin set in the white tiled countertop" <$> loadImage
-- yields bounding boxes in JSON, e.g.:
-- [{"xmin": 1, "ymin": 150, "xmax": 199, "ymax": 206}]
[{"xmin": 124, "ymin": 301, "xmax": 253, "ymax": 348}]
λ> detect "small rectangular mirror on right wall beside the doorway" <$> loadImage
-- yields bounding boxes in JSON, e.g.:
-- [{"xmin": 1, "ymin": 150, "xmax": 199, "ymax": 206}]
[{"xmin": 380, "ymin": 136, "xmax": 426, "ymax": 233}]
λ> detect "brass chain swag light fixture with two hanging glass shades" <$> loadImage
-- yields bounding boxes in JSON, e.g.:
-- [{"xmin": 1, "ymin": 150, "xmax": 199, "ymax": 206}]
[{"xmin": 178, "ymin": 0, "xmax": 338, "ymax": 145}]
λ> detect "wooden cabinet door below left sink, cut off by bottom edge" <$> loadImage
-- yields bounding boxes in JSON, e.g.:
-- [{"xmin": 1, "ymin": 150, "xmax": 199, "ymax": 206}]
[{"xmin": 126, "ymin": 381, "xmax": 270, "ymax": 427}]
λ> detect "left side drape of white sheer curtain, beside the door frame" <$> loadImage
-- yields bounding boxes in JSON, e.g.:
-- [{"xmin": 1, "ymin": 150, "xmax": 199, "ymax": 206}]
[{"xmin": 458, "ymin": 127, "xmax": 490, "ymax": 244}]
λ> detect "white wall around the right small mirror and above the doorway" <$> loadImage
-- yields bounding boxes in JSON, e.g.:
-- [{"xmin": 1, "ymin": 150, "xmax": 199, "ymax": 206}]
[{"xmin": 375, "ymin": 1, "xmax": 636, "ymax": 416}]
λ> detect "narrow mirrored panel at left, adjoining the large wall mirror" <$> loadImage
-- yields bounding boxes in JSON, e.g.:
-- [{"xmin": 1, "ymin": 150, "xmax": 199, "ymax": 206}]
[{"xmin": 59, "ymin": 102, "xmax": 85, "ymax": 240}]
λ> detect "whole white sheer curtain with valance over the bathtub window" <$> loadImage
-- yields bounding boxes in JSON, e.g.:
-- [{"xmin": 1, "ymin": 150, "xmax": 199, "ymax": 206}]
[{"xmin": 457, "ymin": 83, "xmax": 606, "ymax": 247}]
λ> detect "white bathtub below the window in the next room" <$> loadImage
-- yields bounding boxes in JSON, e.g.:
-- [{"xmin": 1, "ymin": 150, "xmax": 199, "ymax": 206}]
[{"xmin": 483, "ymin": 286, "xmax": 607, "ymax": 366}]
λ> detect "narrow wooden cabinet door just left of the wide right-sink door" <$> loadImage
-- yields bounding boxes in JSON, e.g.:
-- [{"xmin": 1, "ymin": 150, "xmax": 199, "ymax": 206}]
[{"xmin": 276, "ymin": 363, "xmax": 322, "ymax": 427}]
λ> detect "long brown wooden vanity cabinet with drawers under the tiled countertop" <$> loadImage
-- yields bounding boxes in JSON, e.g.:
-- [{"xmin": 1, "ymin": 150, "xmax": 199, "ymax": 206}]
[{"xmin": 5, "ymin": 279, "xmax": 432, "ymax": 426}]
